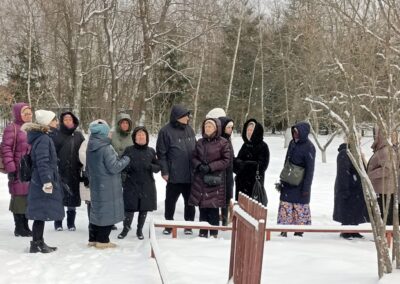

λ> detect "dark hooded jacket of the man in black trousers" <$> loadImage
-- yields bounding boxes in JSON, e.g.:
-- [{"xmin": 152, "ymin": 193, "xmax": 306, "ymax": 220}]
[{"xmin": 156, "ymin": 105, "xmax": 196, "ymax": 183}]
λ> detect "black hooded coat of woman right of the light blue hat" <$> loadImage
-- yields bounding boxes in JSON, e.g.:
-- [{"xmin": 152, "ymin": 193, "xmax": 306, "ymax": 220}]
[{"xmin": 123, "ymin": 127, "xmax": 161, "ymax": 212}]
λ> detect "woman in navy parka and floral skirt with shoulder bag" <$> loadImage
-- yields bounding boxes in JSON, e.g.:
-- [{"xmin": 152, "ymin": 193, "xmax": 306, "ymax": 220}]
[{"xmin": 278, "ymin": 122, "xmax": 315, "ymax": 237}]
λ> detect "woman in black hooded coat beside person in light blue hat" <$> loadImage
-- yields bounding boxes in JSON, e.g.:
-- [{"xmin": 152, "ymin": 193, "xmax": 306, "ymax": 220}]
[{"xmin": 118, "ymin": 126, "xmax": 161, "ymax": 240}]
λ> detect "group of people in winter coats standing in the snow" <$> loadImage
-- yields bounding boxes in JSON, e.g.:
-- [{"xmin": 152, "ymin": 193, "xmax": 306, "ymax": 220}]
[{"xmin": 1, "ymin": 100, "xmax": 398, "ymax": 253}]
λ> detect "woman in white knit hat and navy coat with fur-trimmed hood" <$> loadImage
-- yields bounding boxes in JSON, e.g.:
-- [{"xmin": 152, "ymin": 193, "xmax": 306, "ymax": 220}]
[{"xmin": 22, "ymin": 110, "xmax": 64, "ymax": 253}]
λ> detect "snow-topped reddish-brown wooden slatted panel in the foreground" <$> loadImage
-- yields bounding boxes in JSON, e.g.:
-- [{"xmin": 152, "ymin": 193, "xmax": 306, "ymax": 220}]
[{"xmin": 229, "ymin": 194, "xmax": 267, "ymax": 284}]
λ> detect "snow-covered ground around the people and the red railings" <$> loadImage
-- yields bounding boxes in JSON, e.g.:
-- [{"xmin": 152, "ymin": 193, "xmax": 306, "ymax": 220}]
[{"xmin": 0, "ymin": 136, "xmax": 400, "ymax": 284}]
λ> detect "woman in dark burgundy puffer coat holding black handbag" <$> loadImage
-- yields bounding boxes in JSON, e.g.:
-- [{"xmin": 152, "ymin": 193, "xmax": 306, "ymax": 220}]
[{"xmin": 189, "ymin": 118, "xmax": 231, "ymax": 238}]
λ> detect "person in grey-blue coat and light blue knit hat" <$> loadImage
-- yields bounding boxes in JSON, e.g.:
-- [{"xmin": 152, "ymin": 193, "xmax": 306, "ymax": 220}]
[{"xmin": 86, "ymin": 121, "xmax": 130, "ymax": 249}]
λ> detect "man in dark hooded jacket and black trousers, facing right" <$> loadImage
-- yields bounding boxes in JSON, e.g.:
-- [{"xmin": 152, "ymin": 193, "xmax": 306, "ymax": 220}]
[{"xmin": 156, "ymin": 105, "xmax": 196, "ymax": 235}]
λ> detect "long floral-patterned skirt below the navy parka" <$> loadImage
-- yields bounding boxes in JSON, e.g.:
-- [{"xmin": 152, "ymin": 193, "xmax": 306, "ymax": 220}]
[{"xmin": 278, "ymin": 201, "xmax": 311, "ymax": 225}]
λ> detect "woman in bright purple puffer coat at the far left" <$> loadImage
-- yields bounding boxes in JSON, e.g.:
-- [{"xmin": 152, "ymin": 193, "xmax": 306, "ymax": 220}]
[{"xmin": 0, "ymin": 103, "xmax": 32, "ymax": 237}]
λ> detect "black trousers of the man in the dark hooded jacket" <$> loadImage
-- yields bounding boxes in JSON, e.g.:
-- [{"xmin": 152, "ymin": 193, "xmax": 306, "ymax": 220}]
[{"xmin": 164, "ymin": 183, "xmax": 195, "ymax": 221}]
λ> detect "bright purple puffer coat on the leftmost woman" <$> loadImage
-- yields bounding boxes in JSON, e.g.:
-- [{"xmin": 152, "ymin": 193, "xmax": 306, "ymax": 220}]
[{"xmin": 0, "ymin": 103, "xmax": 30, "ymax": 196}]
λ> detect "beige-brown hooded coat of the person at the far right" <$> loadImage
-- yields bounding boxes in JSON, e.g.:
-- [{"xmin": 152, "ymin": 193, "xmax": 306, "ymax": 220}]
[{"xmin": 367, "ymin": 127, "xmax": 398, "ymax": 194}]
